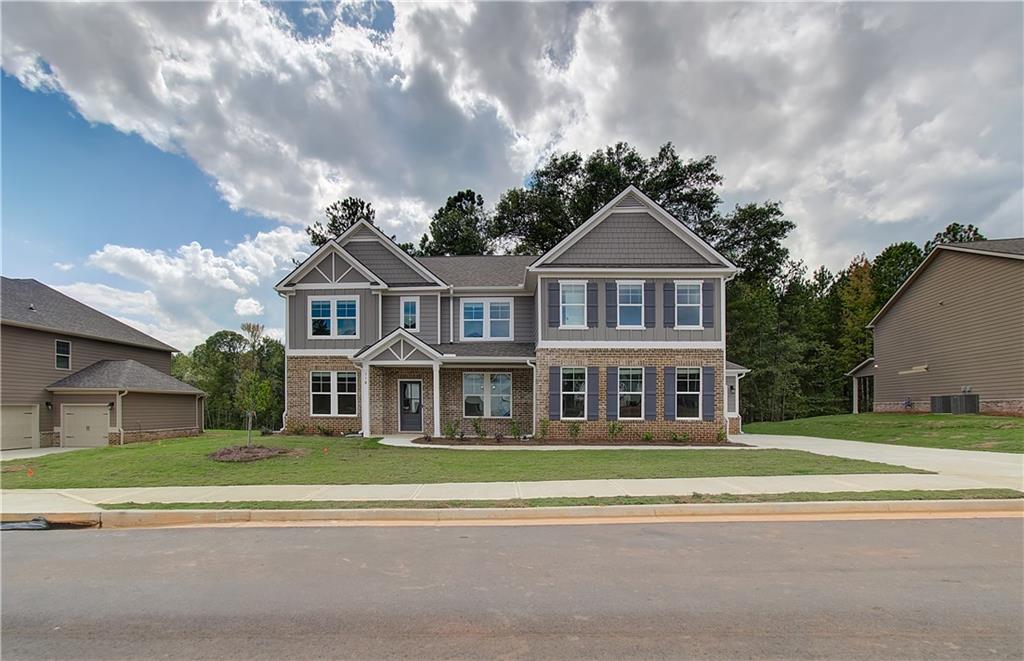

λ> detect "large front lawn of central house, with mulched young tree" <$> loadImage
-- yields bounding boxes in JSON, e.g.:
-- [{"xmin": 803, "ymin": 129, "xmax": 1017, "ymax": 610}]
[{"xmin": 0, "ymin": 431, "xmax": 926, "ymax": 489}]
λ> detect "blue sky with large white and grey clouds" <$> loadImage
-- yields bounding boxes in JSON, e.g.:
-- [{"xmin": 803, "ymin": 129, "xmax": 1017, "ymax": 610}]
[{"xmin": 0, "ymin": 2, "xmax": 1024, "ymax": 350}]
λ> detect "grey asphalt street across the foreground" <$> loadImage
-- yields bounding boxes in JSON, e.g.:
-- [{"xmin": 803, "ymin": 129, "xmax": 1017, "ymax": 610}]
[{"xmin": 0, "ymin": 519, "xmax": 1024, "ymax": 661}]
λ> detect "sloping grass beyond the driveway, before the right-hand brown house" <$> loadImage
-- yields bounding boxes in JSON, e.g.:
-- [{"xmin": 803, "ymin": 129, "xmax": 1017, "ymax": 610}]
[{"xmin": 743, "ymin": 413, "xmax": 1024, "ymax": 452}]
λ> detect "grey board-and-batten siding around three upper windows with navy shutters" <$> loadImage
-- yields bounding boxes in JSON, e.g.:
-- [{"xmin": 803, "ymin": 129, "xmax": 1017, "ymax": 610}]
[{"xmin": 538, "ymin": 274, "xmax": 722, "ymax": 342}]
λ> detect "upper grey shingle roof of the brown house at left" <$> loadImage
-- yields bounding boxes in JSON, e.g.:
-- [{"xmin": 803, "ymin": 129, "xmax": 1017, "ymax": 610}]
[{"xmin": 0, "ymin": 277, "xmax": 177, "ymax": 352}]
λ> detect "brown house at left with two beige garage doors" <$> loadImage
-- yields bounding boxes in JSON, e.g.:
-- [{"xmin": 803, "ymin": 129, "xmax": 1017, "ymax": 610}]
[{"xmin": 0, "ymin": 277, "xmax": 203, "ymax": 450}]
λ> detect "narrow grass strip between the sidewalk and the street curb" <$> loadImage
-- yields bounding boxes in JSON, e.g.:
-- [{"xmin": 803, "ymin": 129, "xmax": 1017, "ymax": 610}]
[{"xmin": 99, "ymin": 489, "xmax": 1024, "ymax": 510}]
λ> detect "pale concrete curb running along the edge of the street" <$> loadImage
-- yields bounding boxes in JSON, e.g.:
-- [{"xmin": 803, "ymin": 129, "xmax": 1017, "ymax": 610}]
[{"xmin": 2, "ymin": 498, "xmax": 1024, "ymax": 528}]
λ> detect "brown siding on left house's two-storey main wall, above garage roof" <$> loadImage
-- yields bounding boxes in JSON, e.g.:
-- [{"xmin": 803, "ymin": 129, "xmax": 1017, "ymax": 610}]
[{"xmin": 0, "ymin": 324, "xmax": 171, "ymax": 432}]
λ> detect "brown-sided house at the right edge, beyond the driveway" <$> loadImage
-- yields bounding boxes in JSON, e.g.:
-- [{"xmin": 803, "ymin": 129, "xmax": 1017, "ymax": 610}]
[{"xmin": 847, "ymin": 238, "xmax": 1024, "ymax": 415}]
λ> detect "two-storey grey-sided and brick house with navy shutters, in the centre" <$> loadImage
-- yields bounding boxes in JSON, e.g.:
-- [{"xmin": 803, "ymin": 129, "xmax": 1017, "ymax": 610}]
[{"xmin": 275, "ymin": 187, "xmax": 746, "ymax": 441}]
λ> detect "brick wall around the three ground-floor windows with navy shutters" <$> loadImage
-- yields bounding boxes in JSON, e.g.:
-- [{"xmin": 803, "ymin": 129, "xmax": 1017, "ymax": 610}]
[{"xmin": 537, "ymin": 348, "xmax": 725, "ymax": 443}]
